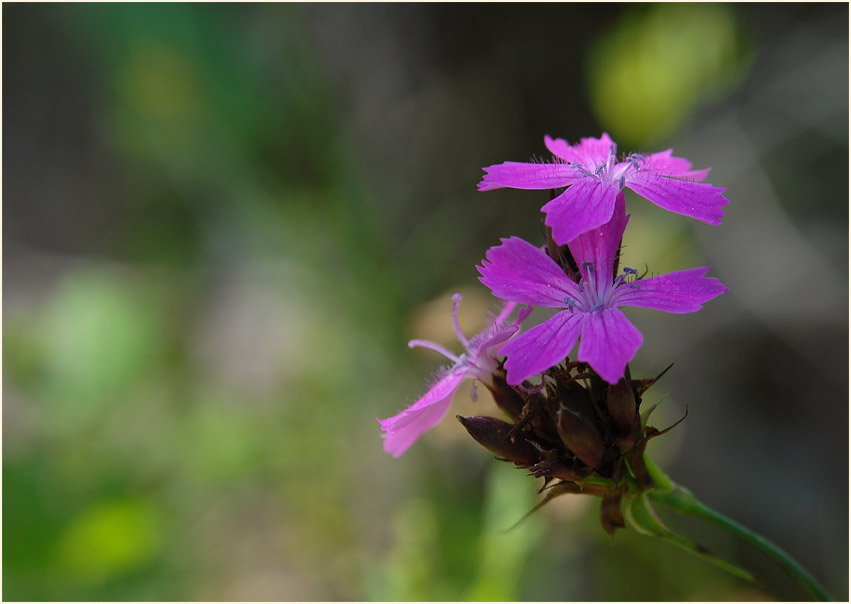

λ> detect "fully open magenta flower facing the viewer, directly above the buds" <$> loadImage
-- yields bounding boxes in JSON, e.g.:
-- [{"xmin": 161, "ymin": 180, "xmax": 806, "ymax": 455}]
[{"xmin": 477, "ymin": 193, "xmax": 727, "ymax": 385}]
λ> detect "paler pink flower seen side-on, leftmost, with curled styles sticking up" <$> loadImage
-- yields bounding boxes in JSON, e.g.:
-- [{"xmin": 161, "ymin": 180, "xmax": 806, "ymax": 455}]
[{"xmin": 378, "ymin": 294, "xmax": 528, "ymax": 457}]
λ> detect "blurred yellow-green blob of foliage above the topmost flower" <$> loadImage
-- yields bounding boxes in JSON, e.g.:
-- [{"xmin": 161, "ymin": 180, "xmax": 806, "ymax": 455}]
[{"xmin": 586, "ymin": 3, "xmax": 748, "ymax": 148}]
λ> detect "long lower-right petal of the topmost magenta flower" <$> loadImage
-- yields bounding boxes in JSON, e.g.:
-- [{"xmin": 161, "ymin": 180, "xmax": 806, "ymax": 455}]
[{"xmin": 626, "ymin": 170, "xmax": 730, "ymax": 224}]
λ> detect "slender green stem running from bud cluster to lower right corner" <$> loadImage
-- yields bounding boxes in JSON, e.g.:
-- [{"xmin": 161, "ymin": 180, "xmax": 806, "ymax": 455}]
[{"xmin": 645, "ymin": 455, "xmax": 835, "ymax": 602}]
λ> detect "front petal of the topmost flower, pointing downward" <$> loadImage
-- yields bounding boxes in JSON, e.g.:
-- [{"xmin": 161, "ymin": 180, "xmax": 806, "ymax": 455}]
[{"xmin": 541, "ymin": 178, "xmax": 618, "ymax": 245}]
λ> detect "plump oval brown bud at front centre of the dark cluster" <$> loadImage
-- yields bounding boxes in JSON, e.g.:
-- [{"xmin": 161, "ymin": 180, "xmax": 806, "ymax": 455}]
[{"xmin": 556, "ymin": 382, "xmax": 606, "ymax": 469}]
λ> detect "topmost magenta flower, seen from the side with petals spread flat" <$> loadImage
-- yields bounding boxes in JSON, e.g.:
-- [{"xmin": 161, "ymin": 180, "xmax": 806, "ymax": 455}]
[{"xmin": 479, "ymin": 133, "xmax": 729, "ymax": 245}]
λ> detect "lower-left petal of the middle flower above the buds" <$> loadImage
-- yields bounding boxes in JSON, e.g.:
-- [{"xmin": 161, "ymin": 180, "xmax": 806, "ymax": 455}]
[{"xmin": 502, "ymin": 310, "xmax": 582, "ymax": 385}]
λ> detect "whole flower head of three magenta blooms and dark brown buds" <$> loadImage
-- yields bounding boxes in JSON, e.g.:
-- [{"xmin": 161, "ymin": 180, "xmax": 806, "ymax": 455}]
[{"xmin": 378, "ymin": 134, "xmax": 728, "ymax": 530}]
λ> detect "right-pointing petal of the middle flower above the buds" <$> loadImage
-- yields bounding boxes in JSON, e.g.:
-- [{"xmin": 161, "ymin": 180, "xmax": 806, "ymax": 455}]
[{"xmin": 613, "ymin": 266, "xmax": 727, "ymax": 313}]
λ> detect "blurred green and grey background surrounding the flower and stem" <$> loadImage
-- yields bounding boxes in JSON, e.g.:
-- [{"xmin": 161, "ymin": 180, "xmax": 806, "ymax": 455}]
[{"xmin": 2, "ymin": 3, "xmax": 849, "ymax": 600}]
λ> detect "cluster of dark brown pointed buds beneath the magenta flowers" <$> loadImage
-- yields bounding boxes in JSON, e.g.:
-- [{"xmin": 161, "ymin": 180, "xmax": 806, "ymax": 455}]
[{"xmin": 457, "ymin": 360, "xmax": 672, "ymax": 533}]
